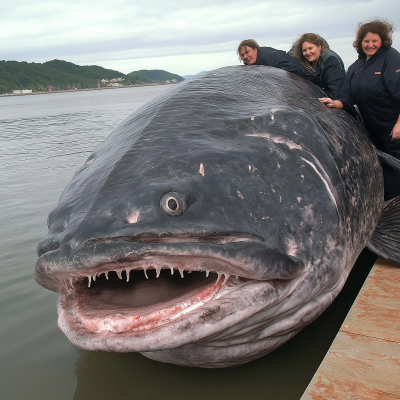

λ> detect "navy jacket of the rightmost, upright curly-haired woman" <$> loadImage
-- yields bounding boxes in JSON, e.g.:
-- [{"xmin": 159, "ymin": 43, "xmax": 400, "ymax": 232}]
[{"xmin": 338, "ymin": 47, "xmax": 400, "ymax": 136}]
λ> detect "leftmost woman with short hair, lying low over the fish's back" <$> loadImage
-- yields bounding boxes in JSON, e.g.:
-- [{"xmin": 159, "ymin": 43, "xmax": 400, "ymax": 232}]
[{"xmin": 237, "ymin": 39, "xmax": 306, "ymax": 78}]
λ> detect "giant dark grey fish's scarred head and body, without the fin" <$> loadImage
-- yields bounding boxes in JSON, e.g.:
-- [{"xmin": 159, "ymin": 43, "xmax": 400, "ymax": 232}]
[{"xmin": 35, "ymin": 66, "xmax": 383, "ymax": 368}]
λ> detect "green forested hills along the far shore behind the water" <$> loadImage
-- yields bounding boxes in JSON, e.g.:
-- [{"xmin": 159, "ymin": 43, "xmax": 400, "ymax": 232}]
[{"xmin": 0, "ymin": 60, "xmax": 183, "ymax": 94}]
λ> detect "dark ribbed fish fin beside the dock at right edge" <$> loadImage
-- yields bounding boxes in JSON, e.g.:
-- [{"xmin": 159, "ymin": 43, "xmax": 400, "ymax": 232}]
[{"xmin": 367, "ymin": 196, "xmax": 400, "ymax": 263}]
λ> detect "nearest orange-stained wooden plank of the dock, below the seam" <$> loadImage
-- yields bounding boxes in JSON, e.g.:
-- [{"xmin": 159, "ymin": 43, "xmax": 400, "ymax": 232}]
[{"xmin": 301, "ymin": 332, "xmax": 400, "ymax": 400}]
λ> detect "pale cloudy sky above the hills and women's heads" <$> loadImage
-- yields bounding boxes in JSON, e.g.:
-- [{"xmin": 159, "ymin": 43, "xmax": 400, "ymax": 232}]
[{"xmin": 0, "ymin": 0, "xmax": 400, "ymax": 75}]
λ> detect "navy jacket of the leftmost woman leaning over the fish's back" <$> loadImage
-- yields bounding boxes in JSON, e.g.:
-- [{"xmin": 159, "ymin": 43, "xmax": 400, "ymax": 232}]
[{"xmin": 250, "ymin": 47, "xmax": 307, "ymax": 79}]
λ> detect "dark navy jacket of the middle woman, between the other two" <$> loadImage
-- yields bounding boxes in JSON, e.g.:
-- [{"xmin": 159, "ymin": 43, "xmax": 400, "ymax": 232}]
[{"xmin": 316, "ymin": 49, "xmax": 346, "ymax": 99}]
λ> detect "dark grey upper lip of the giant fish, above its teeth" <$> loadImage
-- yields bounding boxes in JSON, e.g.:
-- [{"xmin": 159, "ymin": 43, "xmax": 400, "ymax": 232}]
[{"xmin": 34, "ymin": 236, "xmax": 306, "ymax": 293}]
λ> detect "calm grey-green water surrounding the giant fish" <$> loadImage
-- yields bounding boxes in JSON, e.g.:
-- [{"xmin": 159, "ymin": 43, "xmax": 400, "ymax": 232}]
[{"xmin": 0, "ymin": 86, "xmax": 375, "ymax": 400}]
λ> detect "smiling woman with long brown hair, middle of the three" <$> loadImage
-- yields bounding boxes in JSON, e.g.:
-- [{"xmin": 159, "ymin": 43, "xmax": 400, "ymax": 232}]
[{"xmin": 291, "ymin": 33, "xmax": 346, "ymax": 99}]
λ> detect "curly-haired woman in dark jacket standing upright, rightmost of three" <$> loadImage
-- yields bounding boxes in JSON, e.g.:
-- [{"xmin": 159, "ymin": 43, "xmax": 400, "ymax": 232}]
[{"xmin": 319, "ymin": 20, "xmax": 400, "ymax": 199}]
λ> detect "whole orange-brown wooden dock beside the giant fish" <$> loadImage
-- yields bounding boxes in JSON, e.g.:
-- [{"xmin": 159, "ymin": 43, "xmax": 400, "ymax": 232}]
[{"xmin": 301, "ymin": 258, "xmax": 400, "ymax": 400}]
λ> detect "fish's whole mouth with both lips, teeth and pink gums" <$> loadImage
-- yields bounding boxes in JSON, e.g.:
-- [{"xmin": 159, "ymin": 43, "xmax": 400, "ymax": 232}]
[{"xmin": 35, "ymin": 236, "xmax": 304, "ymax": 352}]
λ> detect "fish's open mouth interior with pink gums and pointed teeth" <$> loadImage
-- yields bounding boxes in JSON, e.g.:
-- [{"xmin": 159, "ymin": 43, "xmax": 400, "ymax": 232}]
[{"xmin": 64, "ymin": 262, "xmax": 238, "ymax": 334}]
